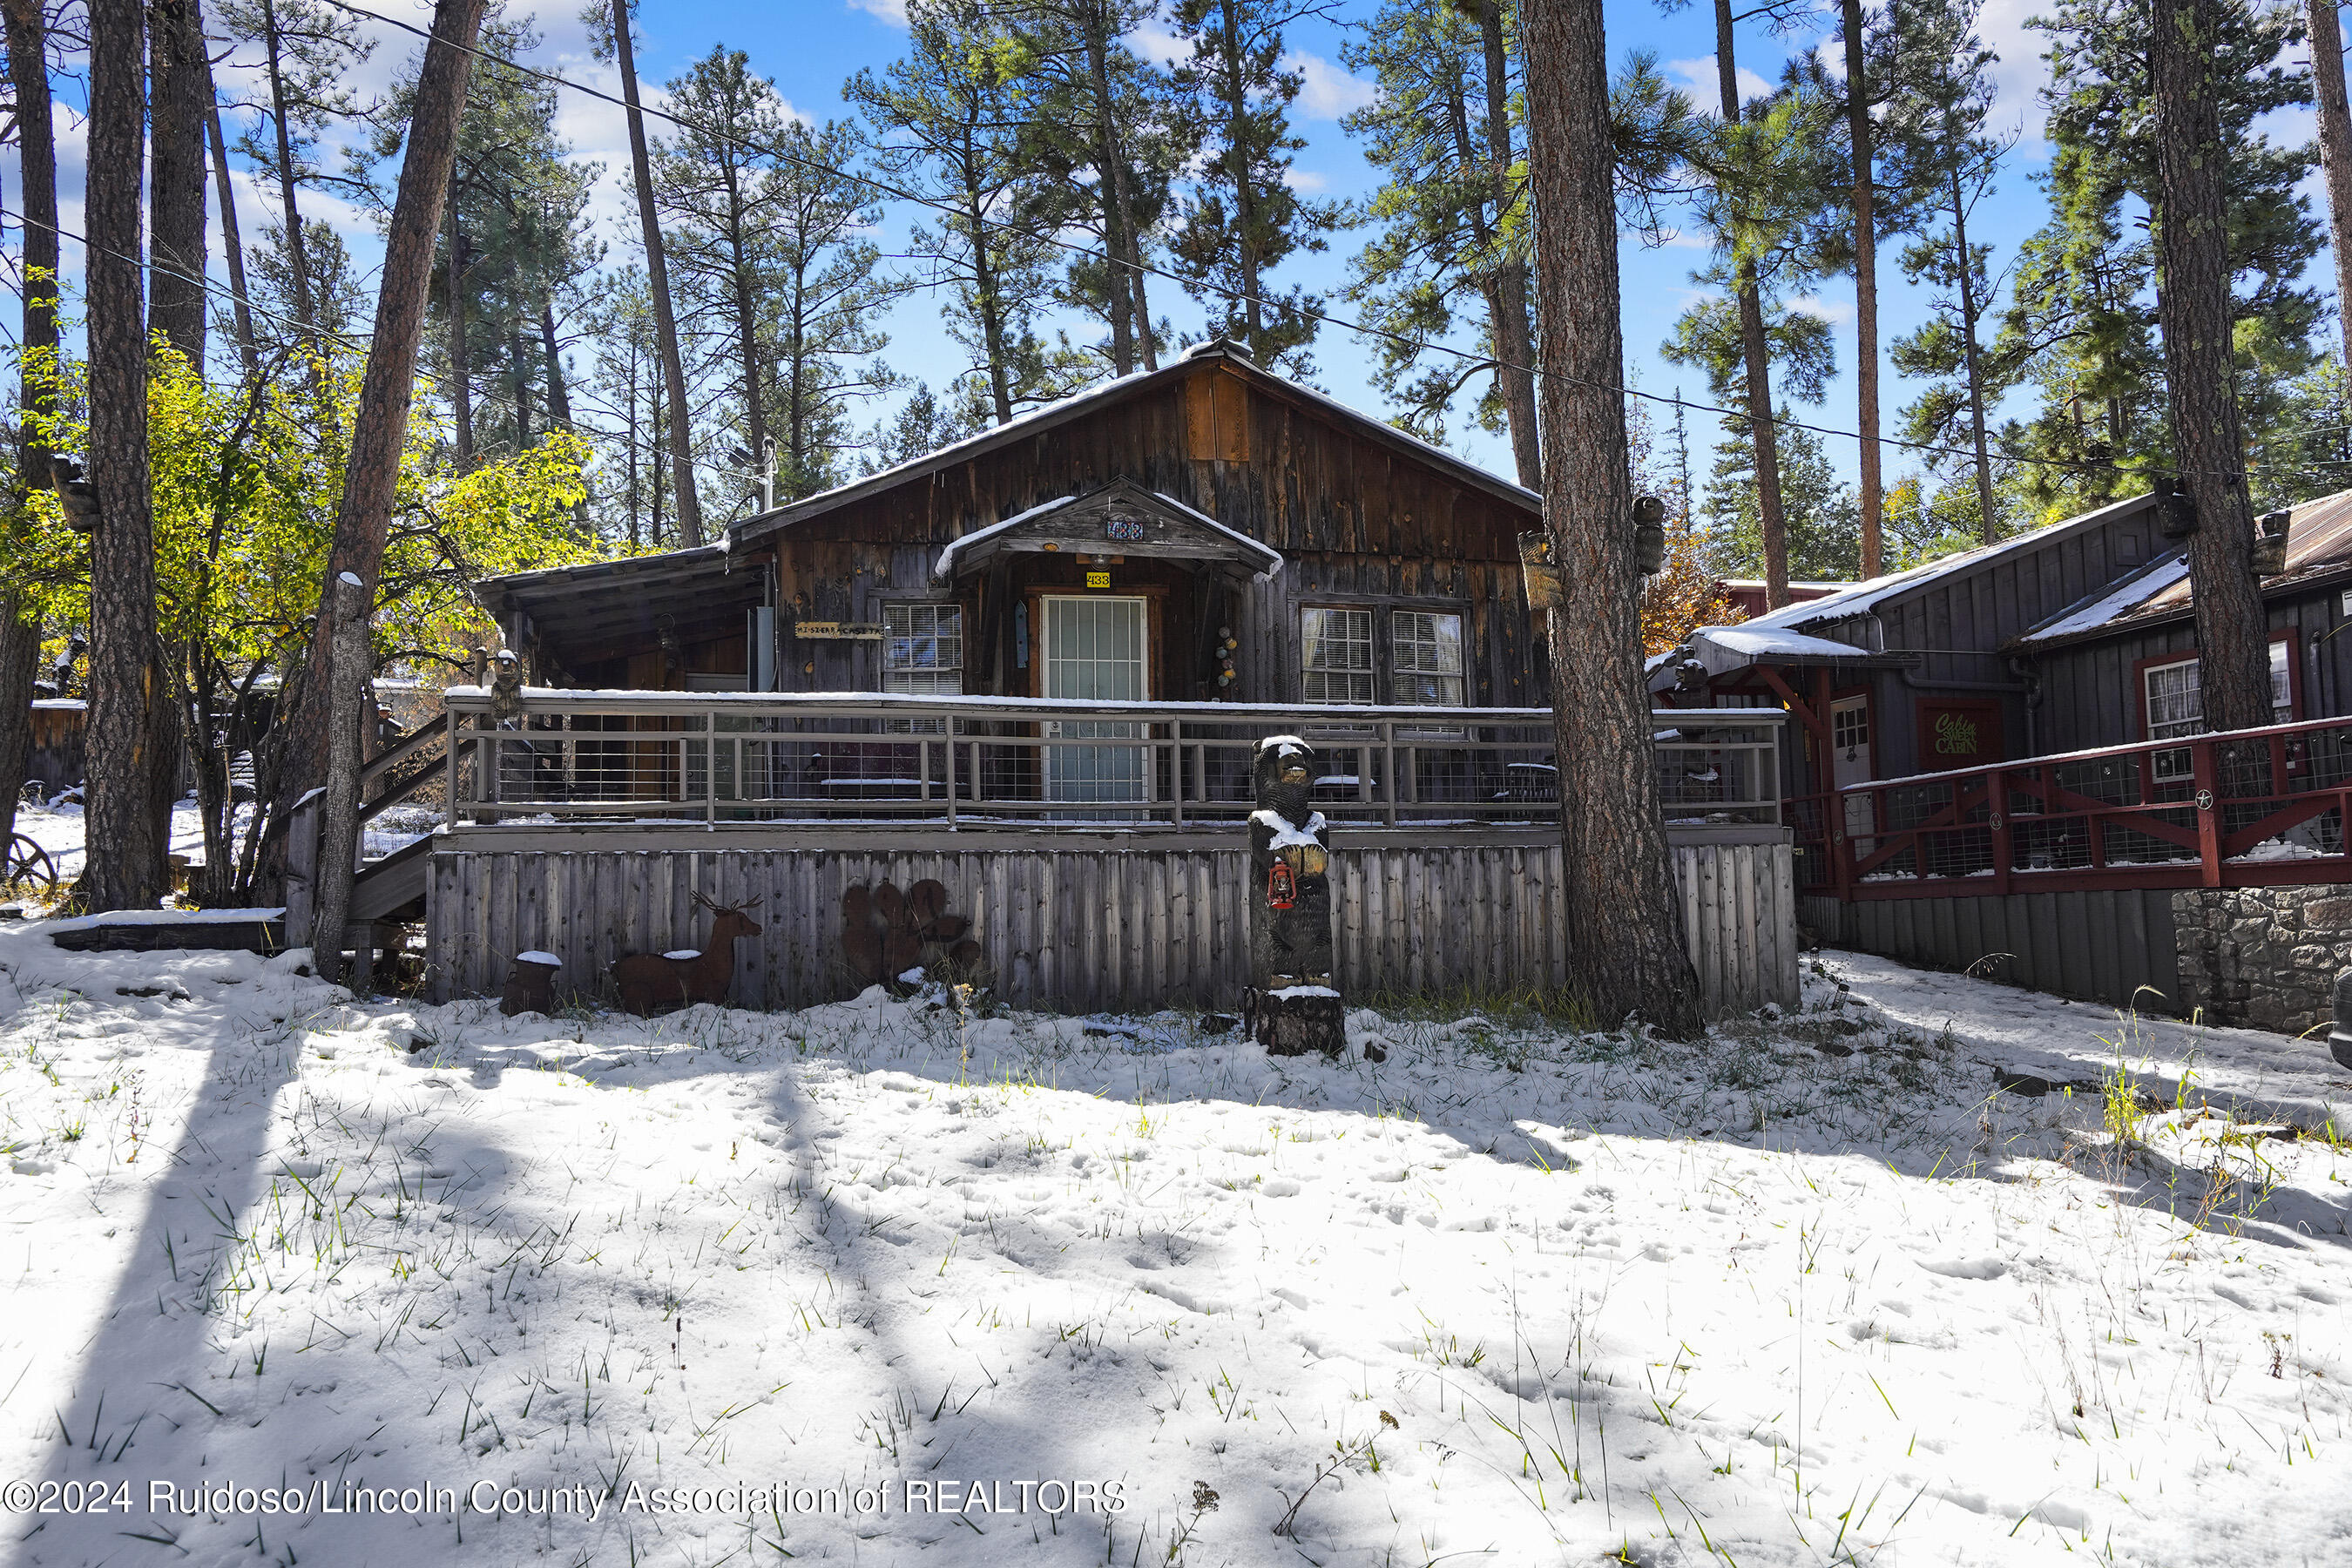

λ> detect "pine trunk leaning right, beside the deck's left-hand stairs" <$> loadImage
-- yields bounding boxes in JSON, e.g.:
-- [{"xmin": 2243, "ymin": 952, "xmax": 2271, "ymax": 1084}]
[{"xmin": 280, "ymin": 0, "xmax": 487, "ymax": 893}]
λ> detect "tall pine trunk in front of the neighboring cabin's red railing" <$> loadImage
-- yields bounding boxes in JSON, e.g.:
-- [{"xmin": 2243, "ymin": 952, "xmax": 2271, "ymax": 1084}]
[{"xmin": 2150, "ymin": 0, "xmax": 2272, "ymax": 731}]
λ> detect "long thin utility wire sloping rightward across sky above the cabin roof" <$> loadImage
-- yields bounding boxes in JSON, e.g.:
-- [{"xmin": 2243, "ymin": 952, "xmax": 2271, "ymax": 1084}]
[{"xmin": 325, "ymin": 0, "xmax": 2267, "ymax": 480}]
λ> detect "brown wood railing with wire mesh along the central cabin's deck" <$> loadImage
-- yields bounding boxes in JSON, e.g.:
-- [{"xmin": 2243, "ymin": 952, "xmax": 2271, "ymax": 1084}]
[{"xmin": 447, "ymin": 686, "xmax": 1785, "ymax": 828}]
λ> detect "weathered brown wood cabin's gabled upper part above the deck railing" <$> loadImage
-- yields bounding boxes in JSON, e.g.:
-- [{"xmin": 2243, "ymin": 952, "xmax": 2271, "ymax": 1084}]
[{"xmin": 480, "ymin": 343, "xmax": 1548, "ymax": 707}]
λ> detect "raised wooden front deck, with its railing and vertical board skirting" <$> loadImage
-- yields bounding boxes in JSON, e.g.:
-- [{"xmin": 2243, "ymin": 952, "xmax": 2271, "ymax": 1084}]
[{"xmin": 409, "ymin": 691, "xmax": 1797, "ymax": 1010}]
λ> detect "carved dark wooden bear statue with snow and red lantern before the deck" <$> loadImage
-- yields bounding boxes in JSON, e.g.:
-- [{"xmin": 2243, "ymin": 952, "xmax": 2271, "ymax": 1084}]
[{"xmin": 1244, "ymin": 736, "xmax": 1348, "ymax": 1056}]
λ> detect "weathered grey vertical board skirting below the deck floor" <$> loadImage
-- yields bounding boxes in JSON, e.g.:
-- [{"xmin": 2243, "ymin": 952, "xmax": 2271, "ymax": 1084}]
[{"xmin": 426, "ymin": 835, "xmax": 1797, "ymax": 1013}]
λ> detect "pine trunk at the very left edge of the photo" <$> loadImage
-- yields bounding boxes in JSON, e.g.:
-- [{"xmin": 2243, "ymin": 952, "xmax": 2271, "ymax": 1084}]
[{"xmin": 0, "ymin": 0, "xmax": 57, "ymax": 860}]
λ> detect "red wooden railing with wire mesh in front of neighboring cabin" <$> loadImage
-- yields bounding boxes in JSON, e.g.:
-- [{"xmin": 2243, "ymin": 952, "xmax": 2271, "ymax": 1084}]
[{"xmin": 1783, "ymin": 720, "xmax": 2352, "ymax": 898}]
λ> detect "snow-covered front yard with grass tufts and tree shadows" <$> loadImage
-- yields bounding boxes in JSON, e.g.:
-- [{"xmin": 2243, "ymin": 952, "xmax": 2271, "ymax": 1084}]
[{"xmin": 0, "ymin": 922, "xmax": 2352, "ymax": 1568}]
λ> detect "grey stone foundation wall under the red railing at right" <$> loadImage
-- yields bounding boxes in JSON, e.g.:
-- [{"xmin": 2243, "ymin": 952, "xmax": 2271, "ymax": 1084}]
[{"xmin": 2173, "ymin": 884, "xmax": 2352, "ymax": 1034}]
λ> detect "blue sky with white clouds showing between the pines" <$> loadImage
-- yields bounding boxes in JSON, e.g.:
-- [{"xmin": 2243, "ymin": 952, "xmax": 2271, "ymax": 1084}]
[{"xmin": 23, "ymin": 0, "xmax": 2326, "ymax": 510}]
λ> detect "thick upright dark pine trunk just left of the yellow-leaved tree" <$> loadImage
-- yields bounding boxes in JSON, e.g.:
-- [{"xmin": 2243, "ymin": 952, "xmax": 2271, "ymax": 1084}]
[{"xmin": 80, "ymin": 0, "xmax": 174, "ymax": 909}]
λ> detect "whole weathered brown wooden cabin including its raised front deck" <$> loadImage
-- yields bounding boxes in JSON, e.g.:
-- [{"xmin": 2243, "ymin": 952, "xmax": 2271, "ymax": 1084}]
[{"xmin": 390, "ymin": 343, "xmax": 1797, "ymax": 1010}]
